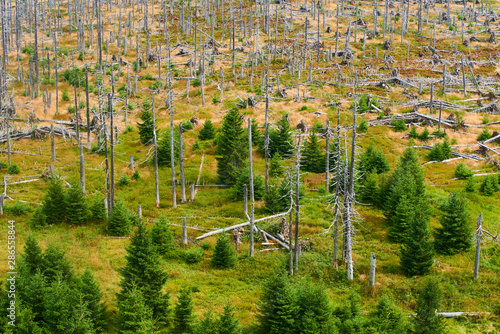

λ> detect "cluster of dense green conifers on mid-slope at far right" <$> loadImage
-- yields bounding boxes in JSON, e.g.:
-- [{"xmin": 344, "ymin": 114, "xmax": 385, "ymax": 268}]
[{"xmin": 358, "ymin": 147, "xmax": 473, "ymax": 276}]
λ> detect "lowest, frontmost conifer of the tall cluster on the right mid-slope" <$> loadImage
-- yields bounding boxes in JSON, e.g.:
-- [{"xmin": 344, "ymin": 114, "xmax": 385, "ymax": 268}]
[{"xmin": 399, "ymin": 211, "xmax": 434, "ymax": 277}]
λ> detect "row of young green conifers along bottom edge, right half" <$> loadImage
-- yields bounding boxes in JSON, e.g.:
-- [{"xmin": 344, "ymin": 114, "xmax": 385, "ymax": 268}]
[{"xmin": 252, "ymin": 271, "xmax": 446, "ymax": 334}]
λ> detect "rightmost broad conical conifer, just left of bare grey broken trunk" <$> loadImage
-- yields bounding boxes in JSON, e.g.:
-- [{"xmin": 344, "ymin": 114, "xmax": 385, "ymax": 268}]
[{"xmin": 434, "ymin": 192, "xmax": 472, "ymax": 255}]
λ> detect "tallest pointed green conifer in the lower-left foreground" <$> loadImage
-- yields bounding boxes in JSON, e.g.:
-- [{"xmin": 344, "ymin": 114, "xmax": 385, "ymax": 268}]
[{"xmin": 117, "ymin": 224, "xmax": 170, "ymax": 328}]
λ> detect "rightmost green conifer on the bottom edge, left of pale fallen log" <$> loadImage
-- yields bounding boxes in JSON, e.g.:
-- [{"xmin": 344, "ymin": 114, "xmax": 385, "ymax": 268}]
[{"xmin": 413, "ymin": 279, "xmax": 446, "ymax": 334}]
